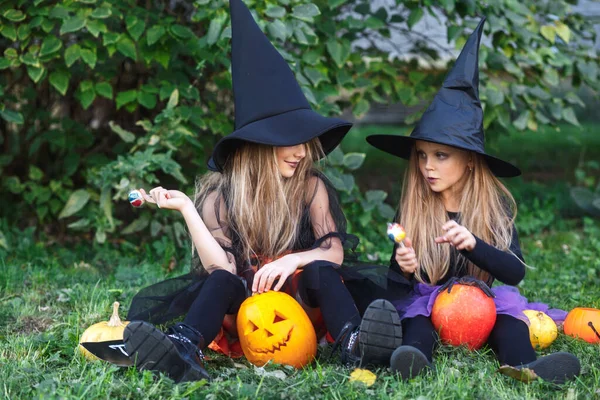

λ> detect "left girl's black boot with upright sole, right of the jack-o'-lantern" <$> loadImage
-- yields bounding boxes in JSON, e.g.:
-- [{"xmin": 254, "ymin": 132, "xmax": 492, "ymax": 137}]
[{"xmin": 336, "ymin": 299, "xmax": 402, "ymax": 366}]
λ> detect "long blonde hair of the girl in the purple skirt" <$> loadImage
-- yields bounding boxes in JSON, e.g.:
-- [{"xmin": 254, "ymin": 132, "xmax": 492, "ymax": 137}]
[{"xmin": 398, "ymin": 146, "xmax": 517, "ymax": 285}]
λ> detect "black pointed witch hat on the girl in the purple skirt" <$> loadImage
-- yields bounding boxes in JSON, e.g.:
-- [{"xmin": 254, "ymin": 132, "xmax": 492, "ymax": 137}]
[{"xmin": 367, "ymin": 17, "xmax": 521, "ymax": 177}]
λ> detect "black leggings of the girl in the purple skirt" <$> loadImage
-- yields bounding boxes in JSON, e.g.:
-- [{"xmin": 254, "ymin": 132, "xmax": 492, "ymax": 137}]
[{"xmin": 402, "ymin": 314, "xmax": 536, "ymax": 366}]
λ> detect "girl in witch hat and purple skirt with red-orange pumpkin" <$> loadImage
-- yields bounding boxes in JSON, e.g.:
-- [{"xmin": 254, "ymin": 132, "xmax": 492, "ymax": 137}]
[{"xmin": 367, "ymin": 19, "xmax": 580, "ymax": 383}]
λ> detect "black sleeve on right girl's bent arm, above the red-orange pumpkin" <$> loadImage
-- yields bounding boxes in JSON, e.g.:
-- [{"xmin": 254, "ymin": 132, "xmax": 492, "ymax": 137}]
[{"xmin": 460, "ymin": 226, "xmax": 525, "ymax": 286}]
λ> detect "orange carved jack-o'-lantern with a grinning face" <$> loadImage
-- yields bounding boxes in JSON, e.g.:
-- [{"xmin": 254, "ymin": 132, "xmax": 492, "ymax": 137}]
[{"xmin": 237, "ymin": 291, "xmax": 317, "ymax": 368}]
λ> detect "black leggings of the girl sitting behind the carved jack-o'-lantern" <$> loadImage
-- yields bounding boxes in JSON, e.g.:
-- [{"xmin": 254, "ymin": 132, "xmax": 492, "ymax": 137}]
[{"xmin": 184, "ymin": 261, "xmax": 360, "ymax": 345}]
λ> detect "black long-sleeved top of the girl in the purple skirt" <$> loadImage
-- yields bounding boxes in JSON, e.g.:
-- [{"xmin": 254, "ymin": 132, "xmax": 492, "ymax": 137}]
[{"xmin": 390, "ymin": 212, "xmax": 525, "ymax": 286}]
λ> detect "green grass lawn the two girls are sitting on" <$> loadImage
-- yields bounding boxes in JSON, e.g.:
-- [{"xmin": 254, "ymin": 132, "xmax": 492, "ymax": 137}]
[{"xmin": 0, "ymin": 219, "xmax": 600, "ymax": 399}]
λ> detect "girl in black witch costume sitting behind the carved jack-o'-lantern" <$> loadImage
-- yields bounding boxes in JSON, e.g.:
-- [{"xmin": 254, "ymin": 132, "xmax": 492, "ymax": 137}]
[{"xmin": 124, "ymin": 0, "xmax": 401, "ymax": 381}]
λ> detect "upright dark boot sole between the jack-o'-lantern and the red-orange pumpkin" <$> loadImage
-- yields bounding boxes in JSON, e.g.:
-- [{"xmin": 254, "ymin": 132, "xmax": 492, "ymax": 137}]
[{"xmin": 358, "ymin": 299, "xmax": 402, "ymax": 366}]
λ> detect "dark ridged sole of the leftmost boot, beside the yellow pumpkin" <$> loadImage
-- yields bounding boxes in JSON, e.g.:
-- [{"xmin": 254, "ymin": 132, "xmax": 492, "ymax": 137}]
[{"xmin": 123, "ymin": 321, "xmax": 206, "ymax": 383}]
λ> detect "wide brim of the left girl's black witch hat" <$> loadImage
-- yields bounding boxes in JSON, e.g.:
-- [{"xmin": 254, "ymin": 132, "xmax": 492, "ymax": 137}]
[{"xmin": 208, "ymin": 109, "xmax": 352, "ymax": 172}]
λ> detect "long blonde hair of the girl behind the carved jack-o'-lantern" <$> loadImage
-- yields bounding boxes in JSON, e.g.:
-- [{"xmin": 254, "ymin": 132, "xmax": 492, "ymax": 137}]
[{"xmin": 194, "ymin": 138, "xmax": 323, "ymax": 269}]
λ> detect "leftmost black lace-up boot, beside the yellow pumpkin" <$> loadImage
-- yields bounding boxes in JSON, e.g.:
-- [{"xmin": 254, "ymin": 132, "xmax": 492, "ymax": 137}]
[{"xmin": 123, "ymin": 321, "xmax": 210, "ymax": 383}]
